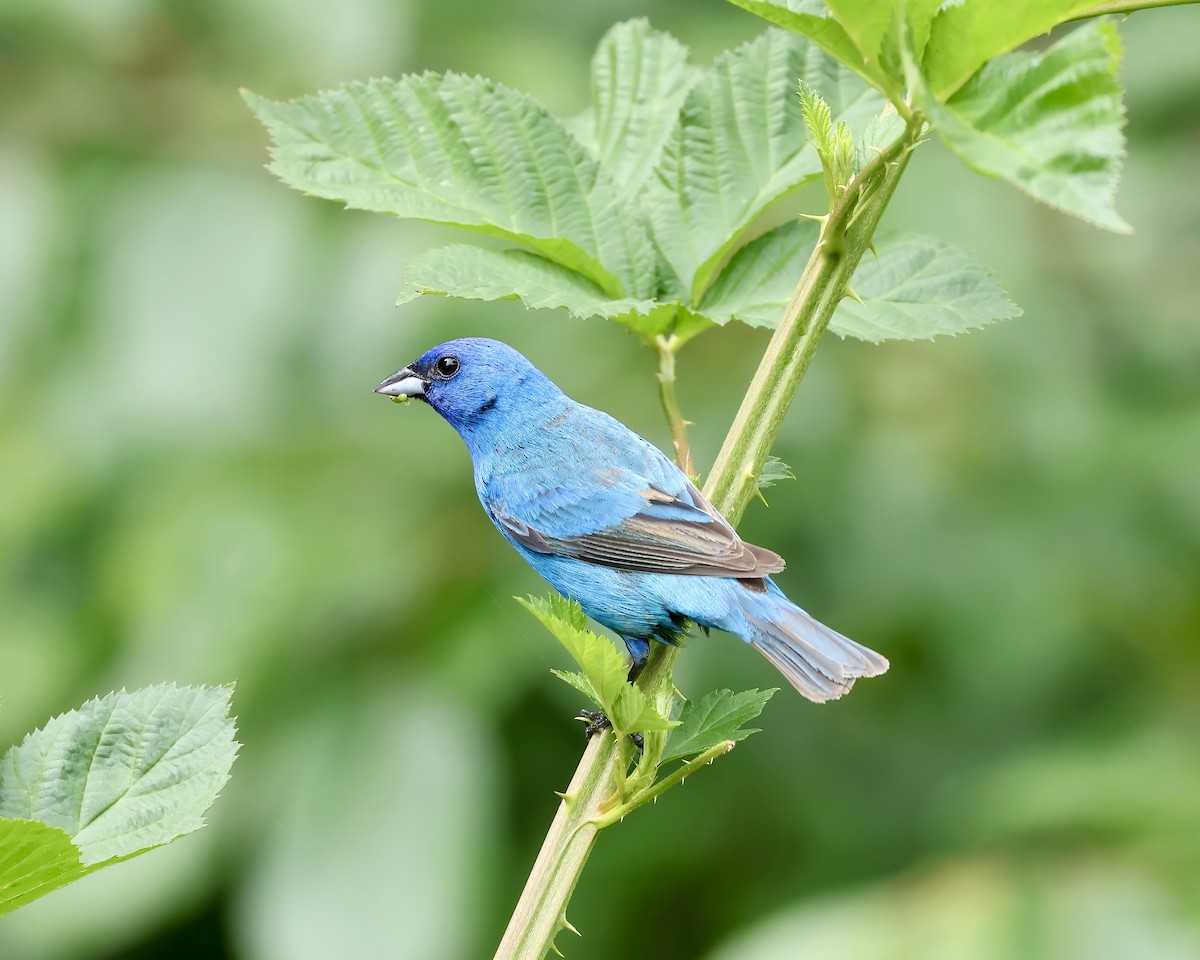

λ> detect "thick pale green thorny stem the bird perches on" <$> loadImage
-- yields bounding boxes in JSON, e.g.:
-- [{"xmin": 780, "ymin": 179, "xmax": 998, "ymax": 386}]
[{"xmin": 496, "ymin": 115, "xmax": 924, "ymax": 960}]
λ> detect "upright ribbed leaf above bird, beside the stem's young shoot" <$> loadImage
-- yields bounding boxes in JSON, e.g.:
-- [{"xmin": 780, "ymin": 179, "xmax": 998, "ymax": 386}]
[{"xmin": 642, "ymin": 30, "xmax": 883, "ymax": 304}]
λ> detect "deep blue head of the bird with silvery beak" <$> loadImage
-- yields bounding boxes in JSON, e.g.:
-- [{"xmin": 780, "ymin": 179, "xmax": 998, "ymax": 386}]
[{"xmin": 376, "ymin": 337, "xmax": 559, "ymax": 442}]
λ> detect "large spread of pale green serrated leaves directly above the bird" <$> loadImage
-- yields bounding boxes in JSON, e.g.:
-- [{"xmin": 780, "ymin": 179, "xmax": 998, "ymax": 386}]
[{"xmin": 246, "ymin": 13, "xmax": 1036, "ymax": 347}]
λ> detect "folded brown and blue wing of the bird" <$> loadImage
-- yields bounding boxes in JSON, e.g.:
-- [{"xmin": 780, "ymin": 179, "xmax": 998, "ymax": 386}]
[{"xmin": 491, "ymin": 475, "xmax": 784, "ymax": 577}]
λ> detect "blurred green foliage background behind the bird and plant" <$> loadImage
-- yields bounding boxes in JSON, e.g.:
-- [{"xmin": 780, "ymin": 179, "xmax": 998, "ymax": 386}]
[{"xmin": 0, "ymin": 0, "xmax": 1200, "ymax": 960}]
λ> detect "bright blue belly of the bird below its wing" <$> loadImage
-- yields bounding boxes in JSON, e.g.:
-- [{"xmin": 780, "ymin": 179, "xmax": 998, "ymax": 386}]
[{"xmin": 517, "ymin": 546, "xmax": 731, "ymax": 637}]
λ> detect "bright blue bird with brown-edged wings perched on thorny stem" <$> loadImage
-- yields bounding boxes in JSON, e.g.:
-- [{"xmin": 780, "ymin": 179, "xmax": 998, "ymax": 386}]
[{"xmin": 376, "ymin": 338, "xmax": 888, "ymax": 703}]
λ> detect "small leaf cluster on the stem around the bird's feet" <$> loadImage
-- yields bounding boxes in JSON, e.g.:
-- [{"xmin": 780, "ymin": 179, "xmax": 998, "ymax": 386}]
[{"xmin": 517, "ymin": 594, "xmax": 775, "ymax": 826}]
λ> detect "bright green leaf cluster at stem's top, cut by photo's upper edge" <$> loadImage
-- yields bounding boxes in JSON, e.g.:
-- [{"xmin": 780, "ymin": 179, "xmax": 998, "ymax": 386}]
[{"xmin": 731, "ymin": 0, "xmax": 1129, "ymax": 230}]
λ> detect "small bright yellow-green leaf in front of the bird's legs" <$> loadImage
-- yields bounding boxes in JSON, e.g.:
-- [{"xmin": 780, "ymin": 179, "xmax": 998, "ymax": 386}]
[{"xmin": 516, "ymin": 595, "xmax": 674, "ymax": 737}]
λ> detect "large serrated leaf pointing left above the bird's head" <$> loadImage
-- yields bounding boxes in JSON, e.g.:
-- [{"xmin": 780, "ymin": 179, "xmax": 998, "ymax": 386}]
[{"xmin": 245, "ymin": 73, "xmax": 656, "ymax": 299}]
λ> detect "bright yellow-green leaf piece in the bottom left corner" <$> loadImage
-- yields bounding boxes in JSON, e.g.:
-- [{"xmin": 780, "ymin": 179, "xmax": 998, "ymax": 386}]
[{"xmin": 0, "ymin": 820, "xmax": 88, "ymax": 916}]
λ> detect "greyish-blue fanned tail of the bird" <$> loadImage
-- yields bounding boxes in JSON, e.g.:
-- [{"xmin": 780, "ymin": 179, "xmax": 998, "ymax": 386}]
[{"xmin": 742, "ymin": 584, "xmax": 889, "ymax": 703}]
